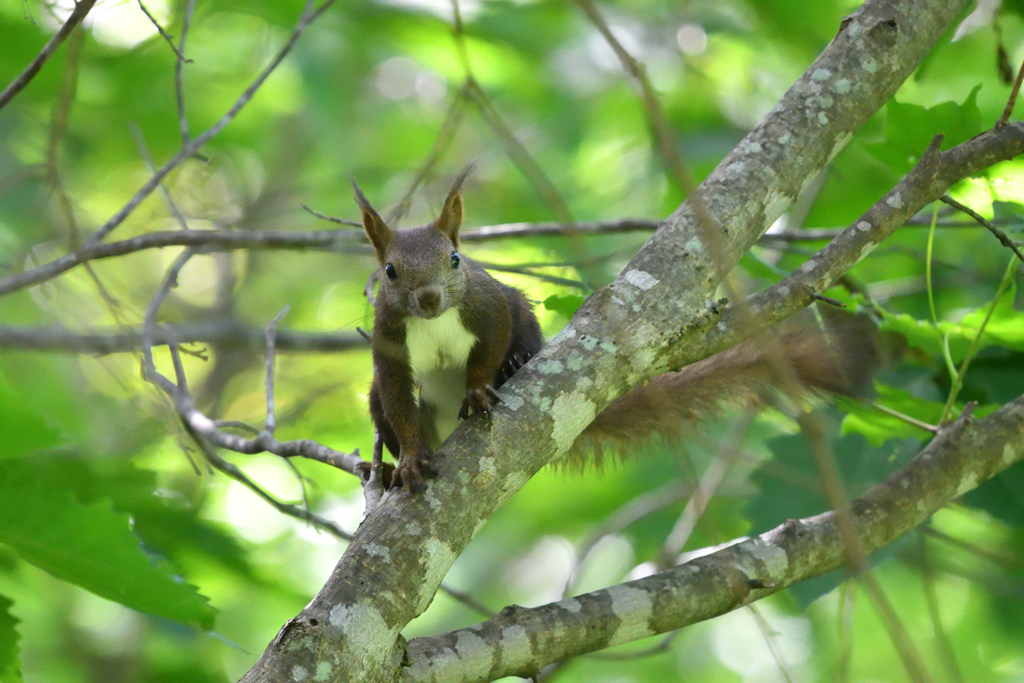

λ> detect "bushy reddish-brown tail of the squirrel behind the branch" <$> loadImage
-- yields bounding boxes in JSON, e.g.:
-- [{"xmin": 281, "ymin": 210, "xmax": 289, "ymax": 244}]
[{"xmin": 558, "ymin": 307, "xmax": 882, "ymax": 469}]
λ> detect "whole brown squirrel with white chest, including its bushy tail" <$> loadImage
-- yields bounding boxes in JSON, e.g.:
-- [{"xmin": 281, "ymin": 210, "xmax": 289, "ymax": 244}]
[{"xmin": 352, "ymin": 167, "xmax": 879, "ymax": 492}]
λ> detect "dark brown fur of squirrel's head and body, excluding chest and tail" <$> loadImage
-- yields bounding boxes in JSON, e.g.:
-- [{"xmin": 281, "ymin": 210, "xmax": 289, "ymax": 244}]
[{"xmin": 352, "ymin": 167, "xmax": 544, "ymax": 489}]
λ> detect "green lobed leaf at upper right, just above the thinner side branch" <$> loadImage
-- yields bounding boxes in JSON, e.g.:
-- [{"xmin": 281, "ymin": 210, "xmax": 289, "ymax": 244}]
[{"xmin": 865, "ymin": 85, "xmax": 981, "ymax": 175}]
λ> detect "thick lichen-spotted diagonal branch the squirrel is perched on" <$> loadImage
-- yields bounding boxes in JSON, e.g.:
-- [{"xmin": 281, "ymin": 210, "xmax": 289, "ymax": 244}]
[{"xmin": 244, "ymin": 0, "xmax": 966, "ymax": 681}]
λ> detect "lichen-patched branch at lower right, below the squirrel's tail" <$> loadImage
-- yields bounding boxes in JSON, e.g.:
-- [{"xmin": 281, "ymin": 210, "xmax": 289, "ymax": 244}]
[{"xmin": 404, "ymin": 396, "xmax": 1024, "ymax": 682}]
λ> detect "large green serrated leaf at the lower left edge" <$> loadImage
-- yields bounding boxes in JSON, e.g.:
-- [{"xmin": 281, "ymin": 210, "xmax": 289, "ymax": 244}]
[{"xmin": 0, "ymin": 459, "xmax": 214, "ymax": 630}]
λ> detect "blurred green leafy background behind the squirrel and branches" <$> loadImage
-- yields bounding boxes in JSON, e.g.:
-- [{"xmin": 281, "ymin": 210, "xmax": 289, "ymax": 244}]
[{"xmin": 0, "ymin": 0, "xmax": 1024, "ymax": 683}]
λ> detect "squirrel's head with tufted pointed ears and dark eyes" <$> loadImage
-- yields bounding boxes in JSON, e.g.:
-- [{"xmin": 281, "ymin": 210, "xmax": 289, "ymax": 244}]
[{"xmin": 352, "ymin": 166, "xmax": 472, "ymax": 318}]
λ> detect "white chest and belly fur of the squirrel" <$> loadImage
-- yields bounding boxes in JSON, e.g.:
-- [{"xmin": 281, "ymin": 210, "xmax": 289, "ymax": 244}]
[{"xmin": 406, "ymin": 308, "xmax": 476, "ymax": 447}]
